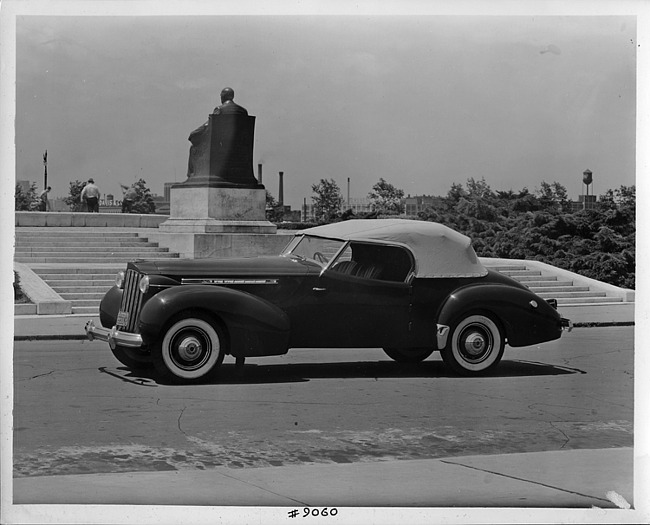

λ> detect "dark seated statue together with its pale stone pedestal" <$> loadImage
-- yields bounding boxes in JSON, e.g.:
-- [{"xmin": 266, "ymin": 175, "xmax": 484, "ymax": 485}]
[{"xmin": 158, "ymin": 88, "xmax": 286, "ymax": 258}]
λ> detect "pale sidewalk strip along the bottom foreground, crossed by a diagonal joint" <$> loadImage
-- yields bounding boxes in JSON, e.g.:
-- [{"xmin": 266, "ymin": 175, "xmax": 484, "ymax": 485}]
[{"xmin": 13, "ymin": 448, "xmax": 633, "ymax": 508}]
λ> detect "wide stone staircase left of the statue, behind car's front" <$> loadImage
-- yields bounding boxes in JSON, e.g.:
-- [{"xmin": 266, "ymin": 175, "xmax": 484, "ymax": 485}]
[{"xmin": 14, "ymin": 228, "xmax": 178, "ymax": 315}]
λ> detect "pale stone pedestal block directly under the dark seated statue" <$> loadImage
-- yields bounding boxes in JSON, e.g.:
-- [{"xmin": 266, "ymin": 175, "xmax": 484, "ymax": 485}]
[{"xmin": 159, "ymin": 185, "xmax": 277, "ymax": 233}]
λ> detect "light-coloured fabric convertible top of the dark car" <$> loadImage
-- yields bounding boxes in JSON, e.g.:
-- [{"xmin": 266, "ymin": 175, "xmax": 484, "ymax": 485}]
[{"xmin": 298, "ymin": 219, "xmax": 487, "ymax": 278}]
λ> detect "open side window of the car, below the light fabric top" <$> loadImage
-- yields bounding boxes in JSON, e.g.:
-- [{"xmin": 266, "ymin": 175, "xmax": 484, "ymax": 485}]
[{"xmin": 332, "ymin": 242, "xmax": 413, "ymax": 282}]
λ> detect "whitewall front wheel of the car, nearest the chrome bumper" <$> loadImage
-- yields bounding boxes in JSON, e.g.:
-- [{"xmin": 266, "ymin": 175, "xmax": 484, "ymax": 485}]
[{"xmin": 152, "ymin": 313, "xmax": 226, "ymax": 383}]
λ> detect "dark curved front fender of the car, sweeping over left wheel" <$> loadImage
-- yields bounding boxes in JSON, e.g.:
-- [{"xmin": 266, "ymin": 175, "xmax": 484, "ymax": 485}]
[{"xmin": 139, "ymin": 285, "xmax": 290, "ymax": 356}]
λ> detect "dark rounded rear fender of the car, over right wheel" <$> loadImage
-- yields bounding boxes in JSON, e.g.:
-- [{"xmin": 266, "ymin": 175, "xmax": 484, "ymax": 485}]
[{"xmin": 437, "ymin": 284, "xmax": 562, "ymax": 349}]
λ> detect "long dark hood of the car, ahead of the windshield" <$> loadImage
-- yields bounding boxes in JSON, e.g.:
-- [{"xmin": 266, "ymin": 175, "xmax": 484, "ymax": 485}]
[{"xmin": 130, "ymin": 256, "xmax": 321, "ymax": 277}]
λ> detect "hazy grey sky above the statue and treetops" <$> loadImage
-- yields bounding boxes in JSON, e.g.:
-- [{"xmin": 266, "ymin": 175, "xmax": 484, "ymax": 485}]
[{"xmin": 10, "ymin": 9, "xmax": 638, "ymax": 208}]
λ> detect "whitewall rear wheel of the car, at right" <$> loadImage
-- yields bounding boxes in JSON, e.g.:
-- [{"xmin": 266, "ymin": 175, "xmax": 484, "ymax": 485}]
[{"xmin": 441, "ymin": 313, "xmax": 505, "ymax": 376}]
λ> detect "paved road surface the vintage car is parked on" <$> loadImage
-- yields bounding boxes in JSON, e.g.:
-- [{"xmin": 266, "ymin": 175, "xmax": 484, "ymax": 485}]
[{"xmin": 14, "ymin": 327, "xmax": 634, "ymax": 477}]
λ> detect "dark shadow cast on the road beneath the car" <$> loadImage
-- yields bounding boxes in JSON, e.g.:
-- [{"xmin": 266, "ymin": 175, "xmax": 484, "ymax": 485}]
[{"xmin": 101, "ymin": 360, "xmax": 586, "ymax": 386}]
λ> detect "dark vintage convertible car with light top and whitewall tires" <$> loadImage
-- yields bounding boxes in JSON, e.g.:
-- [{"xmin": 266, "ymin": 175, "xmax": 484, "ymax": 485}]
[{"xmin": 86, "ymin": 219, "xmax": 571, "ymax": 383}]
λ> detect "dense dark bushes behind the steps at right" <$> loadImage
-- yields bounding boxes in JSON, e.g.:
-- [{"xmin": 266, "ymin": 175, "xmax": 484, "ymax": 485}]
[{"xmin": 418, "ymin": 179, "xmax": 636, "ymax": 289}]
